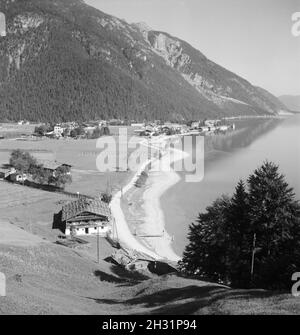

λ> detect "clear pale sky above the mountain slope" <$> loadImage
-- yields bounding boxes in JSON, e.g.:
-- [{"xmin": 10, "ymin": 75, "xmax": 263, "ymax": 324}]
[{"xmin": 85, "ymin": 0, "xmax": 300, "ymax": 96}]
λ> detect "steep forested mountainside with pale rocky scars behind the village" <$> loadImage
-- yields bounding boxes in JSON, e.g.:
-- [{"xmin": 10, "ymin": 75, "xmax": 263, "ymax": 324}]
[{"xmin": 0, "ymin": 0, "xmax": 286, "ymax": 122}]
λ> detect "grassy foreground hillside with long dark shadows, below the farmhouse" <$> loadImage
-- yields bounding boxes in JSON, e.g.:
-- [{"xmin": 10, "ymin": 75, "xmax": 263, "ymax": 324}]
[{"xmin": 0, "ymin": 236, "xmax": 300, "ymax": 315}]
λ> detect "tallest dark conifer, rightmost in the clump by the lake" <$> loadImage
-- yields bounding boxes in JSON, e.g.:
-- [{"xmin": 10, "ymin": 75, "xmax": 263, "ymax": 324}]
[{"xmin": 248, "ymin": 162, "xmax": 300, "ymax": 288}]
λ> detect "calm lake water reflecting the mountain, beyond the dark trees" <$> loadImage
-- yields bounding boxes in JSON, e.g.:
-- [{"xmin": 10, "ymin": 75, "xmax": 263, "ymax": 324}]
[{"xmin": 161, "ymin": 115, "xmax": 300, "ymax": 255}]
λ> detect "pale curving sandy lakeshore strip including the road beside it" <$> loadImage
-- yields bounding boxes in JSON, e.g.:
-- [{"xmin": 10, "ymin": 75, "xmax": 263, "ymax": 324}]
[{"xmin": 111, "ymin": 136, "xmax": 187, "ymax": 262}]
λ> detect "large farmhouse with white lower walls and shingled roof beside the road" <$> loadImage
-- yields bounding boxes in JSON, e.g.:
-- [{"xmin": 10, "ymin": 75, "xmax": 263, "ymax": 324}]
[{"xmin": 62, "ymin": 198, "xmax": 111, "ymax": 236}]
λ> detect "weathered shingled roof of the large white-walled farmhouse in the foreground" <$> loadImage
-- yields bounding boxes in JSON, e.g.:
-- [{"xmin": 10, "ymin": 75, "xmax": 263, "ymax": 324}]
[{"xmin": 62, "ymin": 198, "xmax": 111, "ymax": 221}]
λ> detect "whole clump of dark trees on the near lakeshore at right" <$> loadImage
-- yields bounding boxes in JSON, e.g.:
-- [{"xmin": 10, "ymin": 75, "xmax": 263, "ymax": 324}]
[{"xmin": 180, "ymin": 162, "xmax": 300, "ymax": 289}]
